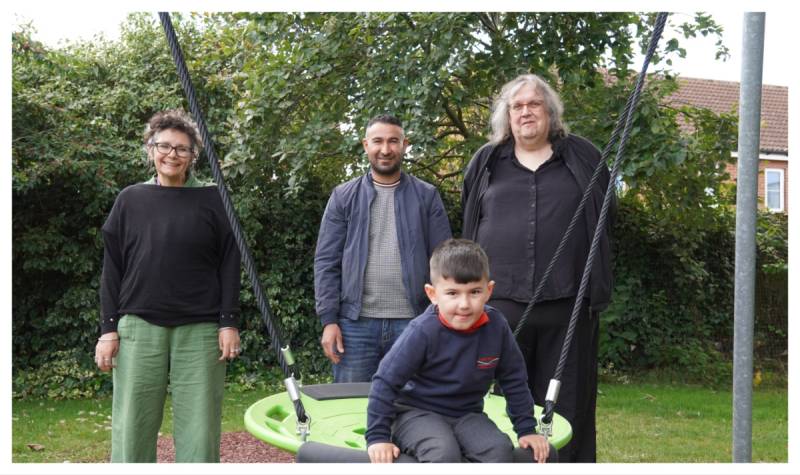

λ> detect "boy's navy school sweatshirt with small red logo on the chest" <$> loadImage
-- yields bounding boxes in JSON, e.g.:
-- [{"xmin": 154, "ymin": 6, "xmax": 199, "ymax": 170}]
[{"xmin": 365, "ymin": 305, "xmax": 536, "ymax": 445}]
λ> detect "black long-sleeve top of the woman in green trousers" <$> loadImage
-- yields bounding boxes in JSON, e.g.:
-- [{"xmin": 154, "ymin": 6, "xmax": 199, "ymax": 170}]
[{"xmin": 100, "ymin": 183, "xmax": 241, "ymax": 333}]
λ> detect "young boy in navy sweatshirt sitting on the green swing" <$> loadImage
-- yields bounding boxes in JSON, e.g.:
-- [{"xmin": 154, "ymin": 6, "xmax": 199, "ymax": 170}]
[{"xmin": 365, "ymin": 239, "xmax": 549, "ymax": 463}]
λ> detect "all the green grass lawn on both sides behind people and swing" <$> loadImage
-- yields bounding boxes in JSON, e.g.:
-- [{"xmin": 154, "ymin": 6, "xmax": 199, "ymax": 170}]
[{"xmin": 12, "ymin": 382, "xmax": 788, "ymax": 463}]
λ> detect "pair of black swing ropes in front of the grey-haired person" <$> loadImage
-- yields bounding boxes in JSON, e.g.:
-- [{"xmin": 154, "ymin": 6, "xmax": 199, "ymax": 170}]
[{"xmin": 514, "ymin": 12, "xmax": 669, "ymax": 436}]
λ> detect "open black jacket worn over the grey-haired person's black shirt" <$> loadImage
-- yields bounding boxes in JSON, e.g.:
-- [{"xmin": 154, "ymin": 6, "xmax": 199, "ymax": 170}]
[{"xmin": 461, "ymin": 134, "xmax": 617, "ymax": 311}]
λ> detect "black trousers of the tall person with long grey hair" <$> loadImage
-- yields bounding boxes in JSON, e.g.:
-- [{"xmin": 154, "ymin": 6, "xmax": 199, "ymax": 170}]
[{"xmin": 489, "ymin": 298, "xmax": 599, "ymax": 462}]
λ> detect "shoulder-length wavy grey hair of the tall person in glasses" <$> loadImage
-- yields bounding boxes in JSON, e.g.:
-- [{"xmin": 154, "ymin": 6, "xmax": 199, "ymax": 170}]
[{"xmin": 489, "ymin": 74, "xmax": 567, "ymax": 144}]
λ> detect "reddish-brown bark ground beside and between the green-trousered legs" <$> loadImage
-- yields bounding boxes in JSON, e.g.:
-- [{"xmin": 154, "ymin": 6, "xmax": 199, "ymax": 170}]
[{"xmin": 156, "ymin": 432, "xmax": 294, "ymax": 463}]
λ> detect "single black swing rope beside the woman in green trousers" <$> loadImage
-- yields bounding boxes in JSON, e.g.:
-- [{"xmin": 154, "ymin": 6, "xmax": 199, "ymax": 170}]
[{"xmin": 158, "ymin": 12, "xmax": 308, "ymax": 426}]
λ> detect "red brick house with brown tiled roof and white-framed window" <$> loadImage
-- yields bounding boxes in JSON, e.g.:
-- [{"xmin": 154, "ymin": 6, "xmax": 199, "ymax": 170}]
[{"xmin": 671, "ymin": 77, "xmax": 789, "ymax": 214}]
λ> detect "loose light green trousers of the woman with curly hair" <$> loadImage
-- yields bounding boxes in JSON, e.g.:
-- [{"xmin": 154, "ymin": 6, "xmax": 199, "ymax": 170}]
[{"xmin": 111, "ymin": 315, "xmax": 226, "ymax": 462}]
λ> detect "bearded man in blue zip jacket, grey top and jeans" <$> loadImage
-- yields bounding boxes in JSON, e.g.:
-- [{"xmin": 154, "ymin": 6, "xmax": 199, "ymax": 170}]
[{"xmin": 314, "ymin": 115, "xmax": 452, "ymax": 383}]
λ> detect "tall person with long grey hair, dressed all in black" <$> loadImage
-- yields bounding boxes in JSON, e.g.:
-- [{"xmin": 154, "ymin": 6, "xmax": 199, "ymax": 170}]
[{"xmin": 461, "ymin": 74, "xmax": 616, "ymax": 462}]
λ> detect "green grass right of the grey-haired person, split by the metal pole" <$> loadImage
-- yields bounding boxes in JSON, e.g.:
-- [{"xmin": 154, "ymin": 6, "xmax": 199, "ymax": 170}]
[{"xmin": 597, "ymin": 383, "xmax": 789, "ymax": 463}]
